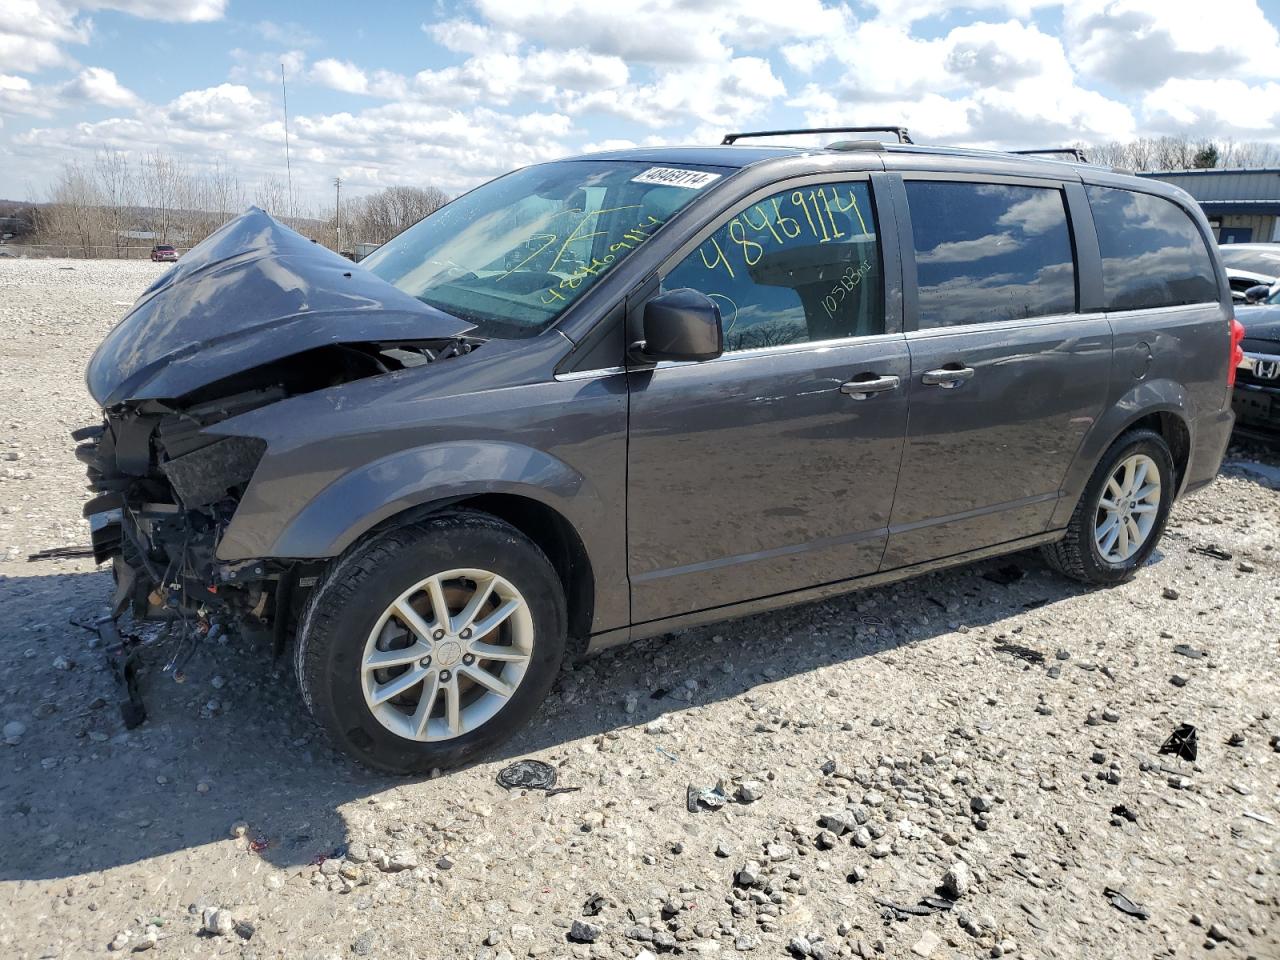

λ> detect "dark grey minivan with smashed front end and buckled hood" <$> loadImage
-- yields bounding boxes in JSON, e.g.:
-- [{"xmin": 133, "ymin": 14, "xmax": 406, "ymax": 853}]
[{"xmin": 74, "ymin": 134, "xmax": 1238, "ymax": 772}]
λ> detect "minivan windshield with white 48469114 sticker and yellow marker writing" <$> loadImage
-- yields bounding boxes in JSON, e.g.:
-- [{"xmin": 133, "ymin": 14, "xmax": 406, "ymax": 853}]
[{"xmin": 361, "ymin": 160, "xmax": 726, "ymax": 337}]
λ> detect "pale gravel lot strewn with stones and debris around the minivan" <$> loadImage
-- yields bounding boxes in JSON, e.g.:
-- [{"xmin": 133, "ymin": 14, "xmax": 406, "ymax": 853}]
[{"xmin": 0, "ymin": 260, "xmax": 1280, "ymax": 960}]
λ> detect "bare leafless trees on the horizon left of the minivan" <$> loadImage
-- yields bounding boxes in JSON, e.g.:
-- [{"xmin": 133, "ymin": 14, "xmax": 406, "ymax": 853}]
[{"xmin": 10, "ymin": 150, "xmax": 449, "ymax": 257}]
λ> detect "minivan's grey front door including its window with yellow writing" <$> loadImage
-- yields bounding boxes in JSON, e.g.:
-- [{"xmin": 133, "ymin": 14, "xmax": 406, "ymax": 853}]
[{"xmin": 627, "ymin": 178, "xmax": 910, "ymax": 623}]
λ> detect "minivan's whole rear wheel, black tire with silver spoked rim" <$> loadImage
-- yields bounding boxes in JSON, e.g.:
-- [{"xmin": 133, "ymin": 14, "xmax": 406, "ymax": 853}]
[{"xmin": 1043, "ymin": 429, "xmax": 1174, "ymax": 585}]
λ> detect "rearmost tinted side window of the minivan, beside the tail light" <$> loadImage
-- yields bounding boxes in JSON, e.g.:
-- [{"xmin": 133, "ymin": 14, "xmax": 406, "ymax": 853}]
[{"xmin": 1088, "ymin": 187, "xmax": 1217, "ymax": 310}]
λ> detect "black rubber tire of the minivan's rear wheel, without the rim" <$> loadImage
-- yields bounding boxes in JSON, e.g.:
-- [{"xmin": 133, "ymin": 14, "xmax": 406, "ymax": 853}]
[{"xmin": 1041, "ymin": 429, "xmax": 1174, "ymax": 586}]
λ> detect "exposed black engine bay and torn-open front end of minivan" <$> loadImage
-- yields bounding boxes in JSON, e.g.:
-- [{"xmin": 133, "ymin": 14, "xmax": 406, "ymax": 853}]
[{"xmin": 80, "ymin": 338, "xmax": 480, "ymax": 644}]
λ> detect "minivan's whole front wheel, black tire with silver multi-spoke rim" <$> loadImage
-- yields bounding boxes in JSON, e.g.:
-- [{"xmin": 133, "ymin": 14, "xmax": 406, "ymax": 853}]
[{"xmin": 294, "ymin": 512, "xmax": 567, "ymax": 774}]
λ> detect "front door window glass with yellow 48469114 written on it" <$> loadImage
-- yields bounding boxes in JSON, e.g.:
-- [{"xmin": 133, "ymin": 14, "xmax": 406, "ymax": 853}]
[{"xmin": 662, "ymin": 180, "xmax": 884, "ymax": 352}]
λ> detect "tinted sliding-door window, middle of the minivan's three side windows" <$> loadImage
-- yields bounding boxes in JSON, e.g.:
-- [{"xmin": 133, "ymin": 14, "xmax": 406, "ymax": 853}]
[{"xmin": 906, "ymin": 180, "xmax": 1075, "ymax": 329}]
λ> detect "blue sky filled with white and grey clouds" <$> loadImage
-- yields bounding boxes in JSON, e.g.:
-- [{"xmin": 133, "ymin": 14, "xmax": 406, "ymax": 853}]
[{"xmin": 0, "ymin": 0, "xmax": 1280, "ymax": 209}]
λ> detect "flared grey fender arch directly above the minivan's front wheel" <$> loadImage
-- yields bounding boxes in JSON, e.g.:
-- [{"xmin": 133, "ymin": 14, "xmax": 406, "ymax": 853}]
[{"xmin": 218, "ymin": 440, "xmax": 593, "ymax": 561}]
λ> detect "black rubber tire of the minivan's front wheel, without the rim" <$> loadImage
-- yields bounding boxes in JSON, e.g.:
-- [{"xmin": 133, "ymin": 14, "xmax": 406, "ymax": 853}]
[{"xmin": 294, "ymin": 512, "xmax": 567, "ymax": 773}]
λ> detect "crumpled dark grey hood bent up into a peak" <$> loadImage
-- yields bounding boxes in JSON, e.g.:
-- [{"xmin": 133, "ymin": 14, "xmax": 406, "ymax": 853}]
[{"xmin": 86, "ymin": 207, "xmax": 471, "ymax": 407}]
